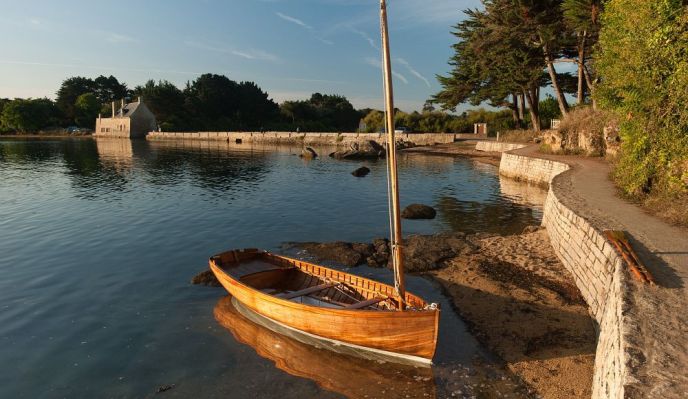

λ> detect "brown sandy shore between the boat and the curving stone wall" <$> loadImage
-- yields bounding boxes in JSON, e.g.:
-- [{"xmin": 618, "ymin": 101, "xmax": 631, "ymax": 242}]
[{"xmin": 430, "ymin": 230, "xmax": 596, "ymax": 398}]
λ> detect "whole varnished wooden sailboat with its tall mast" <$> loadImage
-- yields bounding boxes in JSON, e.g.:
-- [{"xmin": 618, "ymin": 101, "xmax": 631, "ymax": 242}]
[{"xmin": 210, "ymin": 0, "xmax": 439, "ymax": 364}]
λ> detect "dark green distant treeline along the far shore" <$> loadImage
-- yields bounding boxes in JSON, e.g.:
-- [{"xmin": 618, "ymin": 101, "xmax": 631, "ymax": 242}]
[{"xmin": 0, "ymin": 74, "xmax": 547, "ymax": 133}]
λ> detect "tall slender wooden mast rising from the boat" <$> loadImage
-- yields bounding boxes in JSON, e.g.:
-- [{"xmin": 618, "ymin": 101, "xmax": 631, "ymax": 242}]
[{"xmin": 380, "ymin": 0, "xmax": 406, "ymax": 310}]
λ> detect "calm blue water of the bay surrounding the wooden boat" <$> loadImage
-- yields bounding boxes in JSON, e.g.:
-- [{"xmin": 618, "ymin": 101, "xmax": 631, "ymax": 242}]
[{"xmin": 0, "ymin": 139, "xmax": 542, "ymax": 398}]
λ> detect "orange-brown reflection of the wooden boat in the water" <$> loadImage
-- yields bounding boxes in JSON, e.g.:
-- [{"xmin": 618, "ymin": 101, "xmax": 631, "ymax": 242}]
[{"xmin": 214, "ymin": 296, "xmax": 436, "ymax": 398}]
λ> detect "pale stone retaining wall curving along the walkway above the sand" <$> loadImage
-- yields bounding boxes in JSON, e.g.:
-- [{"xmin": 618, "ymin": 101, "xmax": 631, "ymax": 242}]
[{"xmin": 500, "ymin": 147, "xmax": 637, "ymax": 399}]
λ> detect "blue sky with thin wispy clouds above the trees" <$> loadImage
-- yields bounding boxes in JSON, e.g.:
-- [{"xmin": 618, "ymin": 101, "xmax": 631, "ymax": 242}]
[{"xmin": 0, "ymin": 0, "xmax": 480, "ymax": 111}]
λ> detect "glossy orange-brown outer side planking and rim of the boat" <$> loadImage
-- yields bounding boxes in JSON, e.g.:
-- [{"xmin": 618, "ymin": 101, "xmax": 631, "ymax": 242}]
[{"xmin": 210, "ymin": 250, "xmax": 439, "ymax": 362}]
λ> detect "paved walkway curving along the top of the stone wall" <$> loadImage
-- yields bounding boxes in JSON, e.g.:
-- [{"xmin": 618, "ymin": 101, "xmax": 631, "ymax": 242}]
[{"xmin": 512, "ymin": 146, "xmax": 688, "ymax": 397}]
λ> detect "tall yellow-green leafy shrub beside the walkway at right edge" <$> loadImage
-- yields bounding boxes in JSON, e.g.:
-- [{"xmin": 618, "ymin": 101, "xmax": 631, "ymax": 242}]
[{"xmin": 595, "ymin": 0, "xmax": 688, "ymax": 206}]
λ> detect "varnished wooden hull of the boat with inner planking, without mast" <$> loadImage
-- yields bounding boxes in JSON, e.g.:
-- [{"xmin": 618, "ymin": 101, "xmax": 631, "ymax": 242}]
[{"xmin": 210, "ymin": 250, "xmax": 439, "ymax": 362}]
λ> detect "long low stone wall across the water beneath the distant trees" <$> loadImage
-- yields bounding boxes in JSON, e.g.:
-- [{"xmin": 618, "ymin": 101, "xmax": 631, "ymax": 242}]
[{"xmin": 147, "ymin": 132, "xmax": 455, "ymax": 146}]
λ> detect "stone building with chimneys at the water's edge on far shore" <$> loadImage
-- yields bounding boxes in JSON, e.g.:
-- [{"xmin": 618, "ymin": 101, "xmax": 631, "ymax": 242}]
[{"xmin": 94, "ymin": 97, "xmax": 157, "ymax": 138}]
